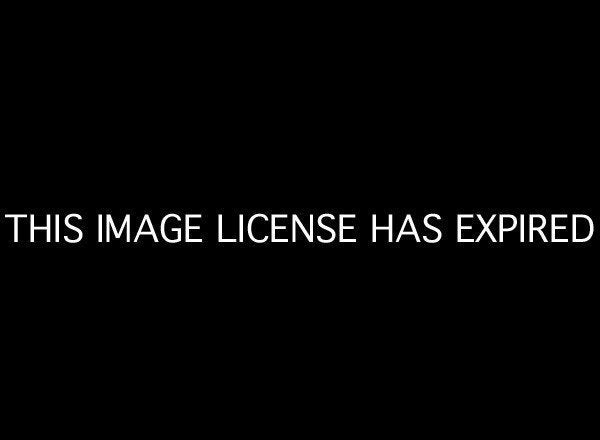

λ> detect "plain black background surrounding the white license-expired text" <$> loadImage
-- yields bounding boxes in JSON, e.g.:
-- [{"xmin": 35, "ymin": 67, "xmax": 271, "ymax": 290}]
[{"xmin": 1, "ymin": 5, "xmax": 598, "ymax": 433}]
